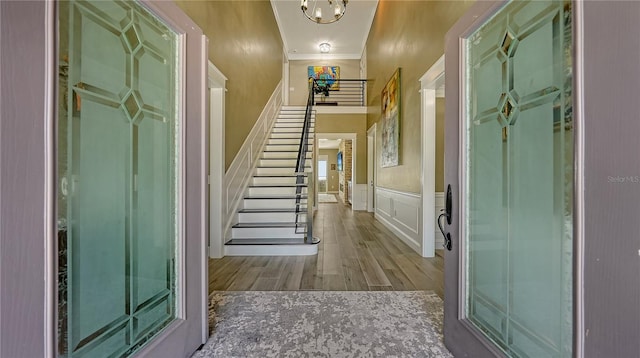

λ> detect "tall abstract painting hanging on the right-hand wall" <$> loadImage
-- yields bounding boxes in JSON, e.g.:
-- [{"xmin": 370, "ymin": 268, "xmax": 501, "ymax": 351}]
[{"xmin": 380, "ymin": 68, "xmax": 400, "ymax": 168}]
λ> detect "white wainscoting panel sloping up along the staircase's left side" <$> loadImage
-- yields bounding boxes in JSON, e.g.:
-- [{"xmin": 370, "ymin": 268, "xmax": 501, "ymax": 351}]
[{"xmin": 223, "ymin": 82, "xmax": 282, "ymax": 241}]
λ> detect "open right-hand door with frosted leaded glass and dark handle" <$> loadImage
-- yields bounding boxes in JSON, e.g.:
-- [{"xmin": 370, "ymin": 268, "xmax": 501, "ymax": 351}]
[{"xmin": 444, "ymin": 1, "xmax": 574, "ymax": 357}]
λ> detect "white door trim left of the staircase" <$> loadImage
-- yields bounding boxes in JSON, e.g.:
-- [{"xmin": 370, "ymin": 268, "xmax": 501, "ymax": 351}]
[{"xmin": 208, "ymin": 61, "xmax": 227, "ymax": 258}]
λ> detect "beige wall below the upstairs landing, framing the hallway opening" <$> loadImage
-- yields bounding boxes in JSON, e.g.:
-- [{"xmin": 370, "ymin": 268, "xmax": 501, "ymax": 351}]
[{"xmin": 315, "ymin": 114, "xmax": 367, "ymax": 184}]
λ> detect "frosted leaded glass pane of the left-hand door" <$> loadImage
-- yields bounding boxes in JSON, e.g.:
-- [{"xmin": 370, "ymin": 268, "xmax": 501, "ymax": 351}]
[{"xmin": 57, "ymin": 1, "xmax": 180, "ymax": 357}]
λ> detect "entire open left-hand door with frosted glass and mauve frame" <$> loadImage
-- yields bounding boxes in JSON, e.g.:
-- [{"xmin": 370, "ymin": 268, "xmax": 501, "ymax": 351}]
[{"xmin": 56, "ymin": 1, "xmax": 206, "ymax": 358}]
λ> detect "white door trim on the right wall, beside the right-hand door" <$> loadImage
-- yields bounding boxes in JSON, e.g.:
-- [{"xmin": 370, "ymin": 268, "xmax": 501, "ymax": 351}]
[{"xmin": 420, "ymin": 55, "xmax": 444, "ymax": 257}]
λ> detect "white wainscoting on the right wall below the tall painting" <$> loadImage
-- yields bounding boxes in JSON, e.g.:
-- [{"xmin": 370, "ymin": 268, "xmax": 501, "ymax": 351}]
[{"xmin": 375, "ymin": 187, "xmax": 422, "ymax": 255}]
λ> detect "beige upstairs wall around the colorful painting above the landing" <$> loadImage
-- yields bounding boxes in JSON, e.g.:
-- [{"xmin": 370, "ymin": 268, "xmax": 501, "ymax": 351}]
[{"xmin": 289, "ymin": 60, "xmax": 360, "ymax": 106}]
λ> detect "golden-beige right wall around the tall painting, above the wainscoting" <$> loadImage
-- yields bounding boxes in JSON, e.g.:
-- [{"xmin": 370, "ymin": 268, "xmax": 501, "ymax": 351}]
[{"xmin": 367, "ymin": 0, "xmax": 472, "ymax": 193}]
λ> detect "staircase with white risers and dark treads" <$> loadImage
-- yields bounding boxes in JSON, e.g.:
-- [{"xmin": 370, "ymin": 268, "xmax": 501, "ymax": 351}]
[{"xmin": 225, "ymin": 106, "xmax": 318, "ymax": 256}]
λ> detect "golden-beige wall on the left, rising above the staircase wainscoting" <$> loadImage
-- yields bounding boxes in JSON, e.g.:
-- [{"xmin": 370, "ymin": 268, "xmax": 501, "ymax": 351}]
[{"xmin": 176, "ymin": 0, "xmax": 283, "ymax": 170}]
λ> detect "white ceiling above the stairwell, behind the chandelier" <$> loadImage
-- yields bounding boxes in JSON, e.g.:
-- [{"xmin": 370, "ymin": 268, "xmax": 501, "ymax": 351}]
[{"xmin": 271, "ymin": 0, "xmax": 378, "ymax": 60}]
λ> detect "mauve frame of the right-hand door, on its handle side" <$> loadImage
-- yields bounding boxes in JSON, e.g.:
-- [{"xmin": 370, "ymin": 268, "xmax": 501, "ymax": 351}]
[{"xmin": 444, "ymin": 0, "xmax": 507, "ymax": 358}]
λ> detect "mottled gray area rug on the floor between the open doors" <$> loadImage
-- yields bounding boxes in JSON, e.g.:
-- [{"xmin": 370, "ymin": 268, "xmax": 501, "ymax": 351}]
[{"xmin": 193, "ymin": 291, "xmax": 453, "ymax": 358}]
